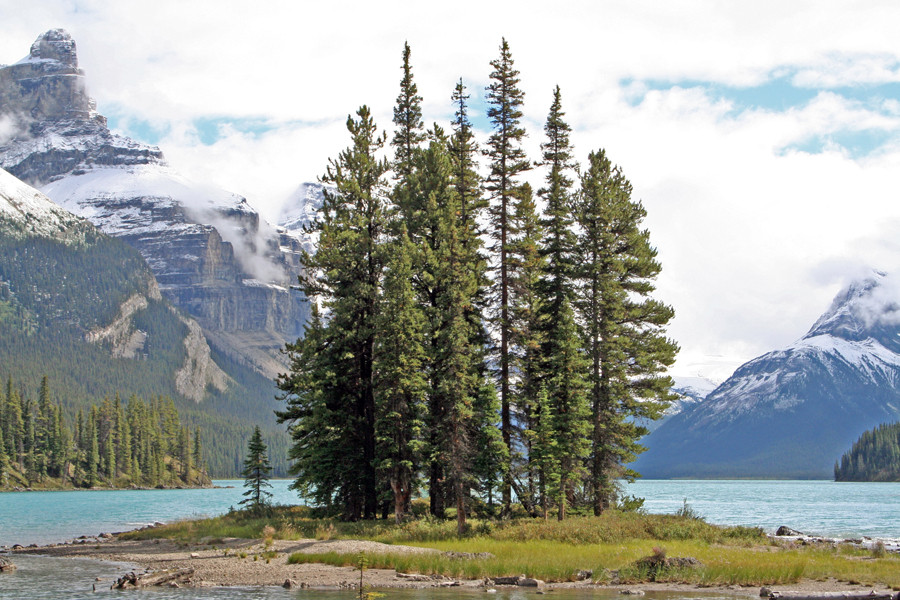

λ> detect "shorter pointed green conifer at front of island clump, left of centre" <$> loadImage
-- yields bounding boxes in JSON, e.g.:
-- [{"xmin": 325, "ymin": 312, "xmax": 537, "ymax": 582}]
[{"xmin": 376, "ymin": 226, "xmax": 428, "ymax": 523}]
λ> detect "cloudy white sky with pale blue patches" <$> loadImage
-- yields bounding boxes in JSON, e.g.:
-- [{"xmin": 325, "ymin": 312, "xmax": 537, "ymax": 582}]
[{"xmin": 0, "ymin": 0, "xmax": 900, "ymax": 381}]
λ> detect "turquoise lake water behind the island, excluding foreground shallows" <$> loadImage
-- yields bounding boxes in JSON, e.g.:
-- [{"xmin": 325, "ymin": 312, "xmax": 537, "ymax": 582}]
[{"xmin": 0, "ymin": 480, "xmax": 900, "ymax": 546}]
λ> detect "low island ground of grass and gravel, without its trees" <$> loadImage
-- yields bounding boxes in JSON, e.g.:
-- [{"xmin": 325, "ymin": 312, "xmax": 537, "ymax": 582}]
[{"xmin": 16, "ymin": 506, "xmax": 900, "ymax": 598}]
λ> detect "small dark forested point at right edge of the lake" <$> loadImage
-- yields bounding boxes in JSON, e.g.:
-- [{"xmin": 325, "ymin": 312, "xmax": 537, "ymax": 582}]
[{"xmin": 834, "ymin": 423, "xmax": 900, "ymax": 481}]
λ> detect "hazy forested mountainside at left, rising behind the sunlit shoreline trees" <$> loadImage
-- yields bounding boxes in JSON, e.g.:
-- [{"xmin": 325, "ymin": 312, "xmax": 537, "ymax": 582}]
[{"xmin": 0, "ymin": 206, "xmax": 289, "ymax": 477}]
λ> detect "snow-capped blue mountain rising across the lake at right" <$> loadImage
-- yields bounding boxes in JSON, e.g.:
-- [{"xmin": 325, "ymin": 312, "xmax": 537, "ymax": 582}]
[{"xmin": 635, "ymin": 273, "xmax": 900, "ymax": 478}]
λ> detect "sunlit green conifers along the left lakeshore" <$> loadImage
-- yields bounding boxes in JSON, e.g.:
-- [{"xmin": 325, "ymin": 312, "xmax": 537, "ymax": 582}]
[{"xmin": 0, "ymin": 377, "xmax": 211, "ymax": 488}]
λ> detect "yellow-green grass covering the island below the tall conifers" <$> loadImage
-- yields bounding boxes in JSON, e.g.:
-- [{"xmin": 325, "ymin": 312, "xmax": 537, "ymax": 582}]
[{"xmin": 123, "ymin": 507, "xmax": 900, "ymax": 590}]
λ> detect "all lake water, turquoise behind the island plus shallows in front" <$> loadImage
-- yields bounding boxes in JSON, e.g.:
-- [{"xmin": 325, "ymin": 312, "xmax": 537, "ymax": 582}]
[{"xmin": 0, "ymin": 480, "xmax": 900, "ymax": 600}]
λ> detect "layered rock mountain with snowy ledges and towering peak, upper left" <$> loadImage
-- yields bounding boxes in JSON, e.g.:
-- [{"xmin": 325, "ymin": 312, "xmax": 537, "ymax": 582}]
[{"xmin": 0, "ymin": 30, "xmax": 308, "ymax": 377}]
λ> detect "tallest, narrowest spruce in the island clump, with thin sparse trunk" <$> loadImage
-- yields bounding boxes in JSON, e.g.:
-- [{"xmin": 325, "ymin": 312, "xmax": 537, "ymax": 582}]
[{"xmin": 485, "ymin": 38, "xmax": 531, "ymax": 513}]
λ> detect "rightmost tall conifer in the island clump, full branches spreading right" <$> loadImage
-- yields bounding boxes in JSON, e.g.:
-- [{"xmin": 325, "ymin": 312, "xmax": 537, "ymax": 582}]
[{"xmin": 576, "ymin": 150, "xmax": 678, "ymax": 515}]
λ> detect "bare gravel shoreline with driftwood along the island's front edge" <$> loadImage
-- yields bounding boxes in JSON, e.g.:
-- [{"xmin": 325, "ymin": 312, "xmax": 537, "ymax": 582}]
[{"xmin": 9, "ymin": 534, "xmax": 895, "ymax": 598}]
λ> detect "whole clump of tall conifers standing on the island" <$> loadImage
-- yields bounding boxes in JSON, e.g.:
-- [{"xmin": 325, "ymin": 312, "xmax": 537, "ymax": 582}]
[{"xmin": 278, "ymin": 40, "xmax": 677, "ymax": 530}]
